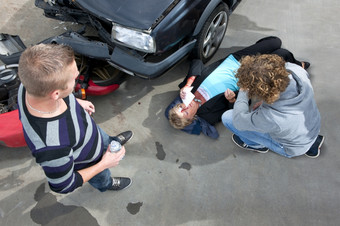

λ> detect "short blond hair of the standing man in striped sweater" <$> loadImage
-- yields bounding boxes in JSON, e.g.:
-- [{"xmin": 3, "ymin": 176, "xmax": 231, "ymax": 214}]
[{"xmin": 19, "ymin": 44, "xmax": 74, "ymax": 97}]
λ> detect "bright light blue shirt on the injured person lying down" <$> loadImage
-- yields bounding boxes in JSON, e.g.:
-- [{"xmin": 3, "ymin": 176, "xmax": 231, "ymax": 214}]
[{"xmin": 197, "ymin": 54, "xmax": 241, "ymax": 101}]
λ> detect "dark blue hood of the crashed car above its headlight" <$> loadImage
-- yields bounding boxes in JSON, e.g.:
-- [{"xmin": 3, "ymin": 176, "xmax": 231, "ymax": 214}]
[{"xmin": 75, "ymin": 0, "xmax": 174, "ymax": 30}]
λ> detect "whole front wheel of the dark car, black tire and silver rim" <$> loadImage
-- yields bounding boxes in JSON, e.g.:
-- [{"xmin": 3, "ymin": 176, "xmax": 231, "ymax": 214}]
[{"xmin": 191, "ymin": 3, "xmax": 229, "ymax": 63}]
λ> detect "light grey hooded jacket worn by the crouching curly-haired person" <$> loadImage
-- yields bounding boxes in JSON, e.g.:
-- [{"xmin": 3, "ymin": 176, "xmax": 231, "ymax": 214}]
[{"xmin": 233, "ymin": 63, "xmax": 320, "ymax": 156}]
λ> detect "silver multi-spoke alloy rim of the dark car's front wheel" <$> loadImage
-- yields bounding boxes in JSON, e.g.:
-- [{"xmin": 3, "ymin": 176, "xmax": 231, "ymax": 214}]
[{"xmin": 202, "ymin": 11, "xmax": 228, "ymax": 58}]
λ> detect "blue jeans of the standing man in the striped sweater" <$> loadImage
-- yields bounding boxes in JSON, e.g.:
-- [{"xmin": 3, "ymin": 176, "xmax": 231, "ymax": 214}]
[{"xmin": 89, "ymin": 126, "xmax": 114, "ymax": 192}]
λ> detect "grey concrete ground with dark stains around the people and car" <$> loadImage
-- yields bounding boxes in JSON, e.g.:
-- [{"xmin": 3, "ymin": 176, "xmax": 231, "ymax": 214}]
[{"xmin": 0, "ymin": 0, "xmax": 340, "ymax": 226}]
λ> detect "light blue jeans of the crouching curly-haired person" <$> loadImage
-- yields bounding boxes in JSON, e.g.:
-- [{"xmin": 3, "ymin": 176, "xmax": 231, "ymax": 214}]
[{"xmin": 222, "ymin": 110, "xmax": 294, "ymax": 158}]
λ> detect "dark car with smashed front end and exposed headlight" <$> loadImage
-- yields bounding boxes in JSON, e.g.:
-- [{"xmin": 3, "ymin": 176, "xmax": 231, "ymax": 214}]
[{"xmin": 35, "ymin": 0, "xmax": 241, "ymax": 78}]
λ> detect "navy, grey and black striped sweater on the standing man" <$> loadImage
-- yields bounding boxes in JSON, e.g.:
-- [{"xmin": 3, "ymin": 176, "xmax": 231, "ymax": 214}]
[{"xmin": 18, "ymin": 85, "xmax": 104, "ymax": 193}]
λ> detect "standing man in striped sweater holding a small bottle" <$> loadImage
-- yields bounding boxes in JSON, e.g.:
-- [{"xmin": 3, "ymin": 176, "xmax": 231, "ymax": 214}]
[{"xmin": 18, "ymin": 44, "xmax": 132, "ymax": 193}]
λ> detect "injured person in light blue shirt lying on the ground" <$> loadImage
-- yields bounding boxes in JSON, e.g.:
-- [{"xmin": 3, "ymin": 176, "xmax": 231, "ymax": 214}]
[{"xmin": 165, "ymin": 36, "xmax": 304, "ymax": 139}]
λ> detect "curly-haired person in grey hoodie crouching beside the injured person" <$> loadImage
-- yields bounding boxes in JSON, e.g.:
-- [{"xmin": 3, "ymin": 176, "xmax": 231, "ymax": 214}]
[{"xmin": 222, "ymin": 54, "xmax": 324, "ymax": 158}]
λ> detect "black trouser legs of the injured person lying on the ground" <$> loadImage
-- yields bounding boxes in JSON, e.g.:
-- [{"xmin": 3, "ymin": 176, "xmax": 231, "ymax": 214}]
[{"xmin": 232, "ymin": 36, "xmax": 302, "ymax": 66}]
